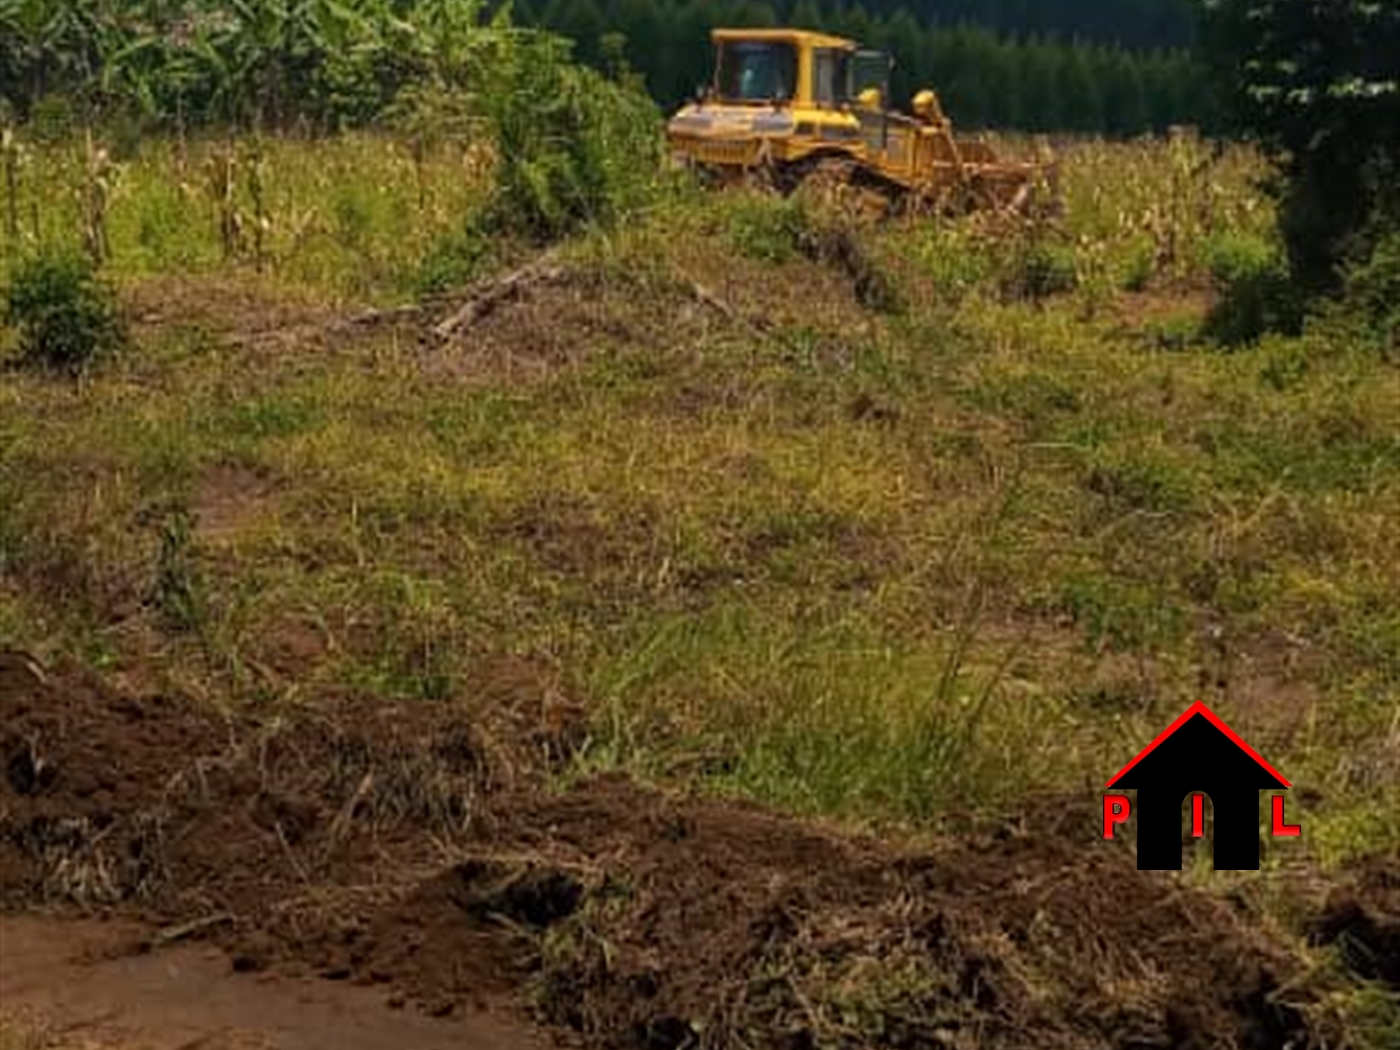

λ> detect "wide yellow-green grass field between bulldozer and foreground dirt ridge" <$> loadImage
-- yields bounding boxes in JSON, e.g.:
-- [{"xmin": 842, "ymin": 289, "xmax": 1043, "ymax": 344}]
[{"xmin": 0, "ymin": 137, "xmax": 1400, "ymax": 1050}]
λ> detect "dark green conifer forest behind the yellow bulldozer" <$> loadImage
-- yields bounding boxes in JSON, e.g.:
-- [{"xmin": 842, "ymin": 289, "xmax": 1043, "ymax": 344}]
[{"xmin": 512, "ymin": 0, "xmax": 1214, "ymax": 134}]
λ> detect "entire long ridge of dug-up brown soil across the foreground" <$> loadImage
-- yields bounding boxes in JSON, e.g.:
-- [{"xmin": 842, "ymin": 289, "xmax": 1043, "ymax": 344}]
[{"xmin": 0, "ymin": 654, "xmax": 1308, "ymax": 1049}]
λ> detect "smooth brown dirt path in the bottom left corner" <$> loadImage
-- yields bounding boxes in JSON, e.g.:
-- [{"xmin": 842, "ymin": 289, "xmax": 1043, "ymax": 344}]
[{"xmin": 0, "ymin": 916, "xmax": 556, "ymax": 1050}]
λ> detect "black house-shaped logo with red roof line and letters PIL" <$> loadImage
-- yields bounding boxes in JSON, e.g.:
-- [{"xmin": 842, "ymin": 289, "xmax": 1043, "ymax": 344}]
[{"xmin": 1103, "ymin": 703, "xmax": 1301, "ymax": 871}]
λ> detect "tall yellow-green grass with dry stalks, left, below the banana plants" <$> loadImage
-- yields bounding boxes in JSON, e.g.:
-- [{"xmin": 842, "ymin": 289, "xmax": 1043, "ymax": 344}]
[{"xmin": 0, "ymin": 133, "xmax": 489, "ymax": 301}]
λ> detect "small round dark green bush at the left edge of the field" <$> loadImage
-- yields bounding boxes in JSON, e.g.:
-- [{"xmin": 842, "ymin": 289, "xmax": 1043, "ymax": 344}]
[{"xmin": 4, "ymin": 255, "xmax": 126, "ymax": 372}]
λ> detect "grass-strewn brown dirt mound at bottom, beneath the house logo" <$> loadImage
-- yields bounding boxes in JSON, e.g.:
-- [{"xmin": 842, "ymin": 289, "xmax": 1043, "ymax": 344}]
[{"xmin": 501, "ymin": 780, "xmax": 1303, "ymax": 1047}]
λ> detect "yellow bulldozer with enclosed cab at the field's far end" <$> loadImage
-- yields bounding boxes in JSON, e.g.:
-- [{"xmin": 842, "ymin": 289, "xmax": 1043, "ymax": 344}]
[{"xmin": 666, "ymin": 29, "xmax": 1053, "ymax": 210}]
